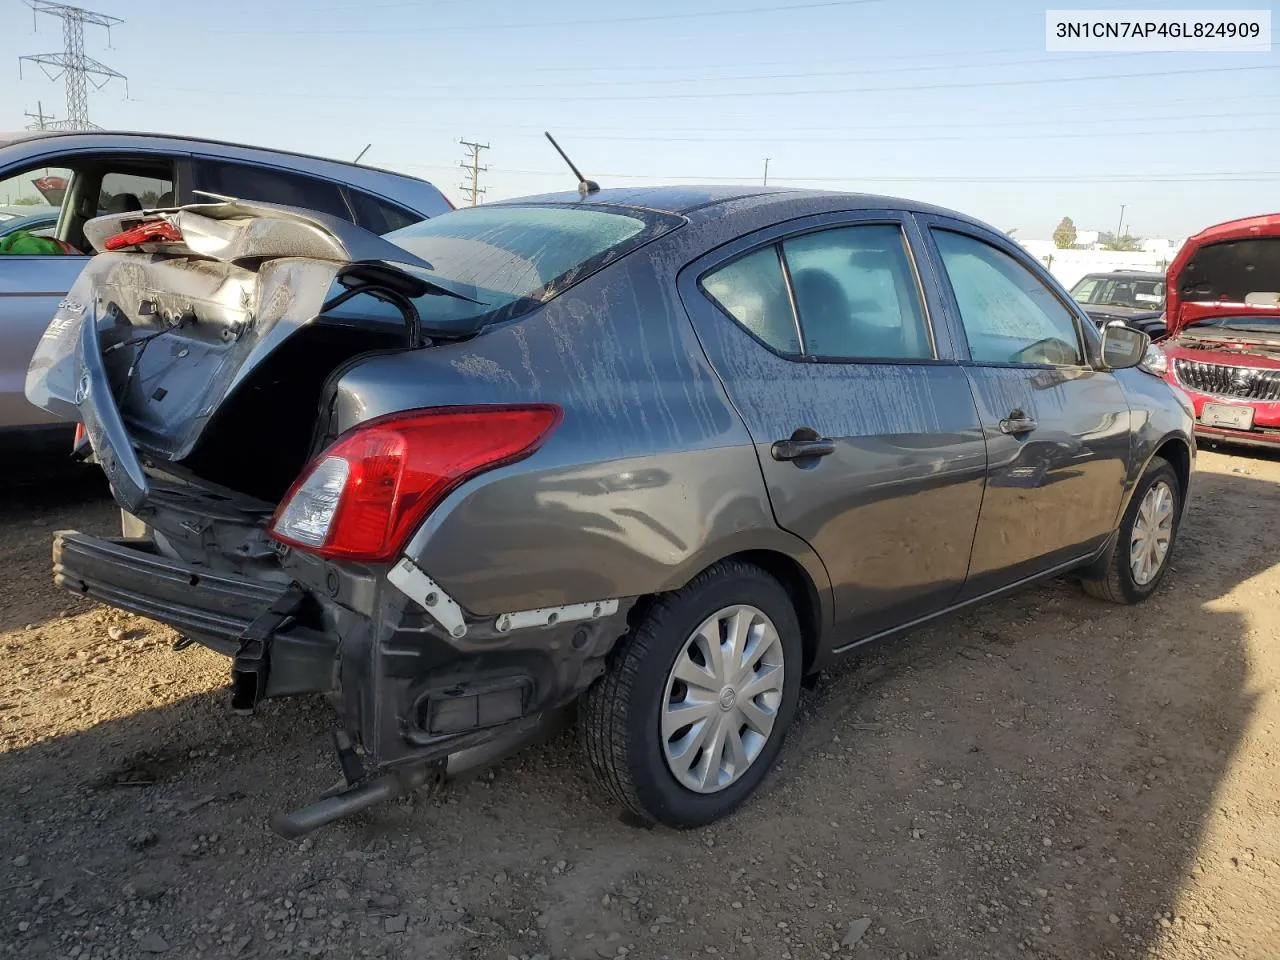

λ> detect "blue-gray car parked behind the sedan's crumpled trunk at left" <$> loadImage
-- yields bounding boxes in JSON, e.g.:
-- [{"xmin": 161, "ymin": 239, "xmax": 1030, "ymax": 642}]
[{"xmin": 0, "ymin": 132, "xmax": 452, "ymax": 451}]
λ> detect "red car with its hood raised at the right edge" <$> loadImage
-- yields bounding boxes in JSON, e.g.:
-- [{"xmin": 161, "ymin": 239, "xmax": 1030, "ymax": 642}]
[{"xmin": 1160, "ymin": 214, "xmax": 1280, "ymax": 447}]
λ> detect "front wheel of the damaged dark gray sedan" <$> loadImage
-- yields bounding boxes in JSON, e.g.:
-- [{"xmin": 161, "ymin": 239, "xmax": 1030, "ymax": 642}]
[{"xmin": 1083, "ymin": 457, "xmax": 1181, "ymax": 603}]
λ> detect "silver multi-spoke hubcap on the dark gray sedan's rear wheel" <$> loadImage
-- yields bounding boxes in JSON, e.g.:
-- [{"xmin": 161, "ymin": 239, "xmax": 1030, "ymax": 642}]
[{"xmin": 662, "ymin": 604, "xmax": 785, "ymax": 794}]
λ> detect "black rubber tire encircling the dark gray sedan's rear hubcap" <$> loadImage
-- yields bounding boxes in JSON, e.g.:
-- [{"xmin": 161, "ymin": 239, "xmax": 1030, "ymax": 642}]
[{"xmin": 579, "ymin": 561, "xmax": 804, "ymax": 827}]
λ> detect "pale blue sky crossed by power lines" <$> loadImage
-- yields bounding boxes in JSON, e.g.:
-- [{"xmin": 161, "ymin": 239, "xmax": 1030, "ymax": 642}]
[{"xmin": 0, "ymin": 0, "xmax": 1280, "ymax": 239}]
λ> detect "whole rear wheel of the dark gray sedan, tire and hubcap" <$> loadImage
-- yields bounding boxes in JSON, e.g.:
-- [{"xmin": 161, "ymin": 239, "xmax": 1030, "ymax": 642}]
[{"xmin": 579, "ymin": 561, "xmax": 803, "ymax": 827}]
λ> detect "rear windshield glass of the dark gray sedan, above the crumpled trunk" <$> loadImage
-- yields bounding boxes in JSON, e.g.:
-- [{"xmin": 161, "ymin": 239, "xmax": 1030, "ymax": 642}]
[{"xmin": 387, "ymin": 204, "xmax": 684, "ymax": 328}]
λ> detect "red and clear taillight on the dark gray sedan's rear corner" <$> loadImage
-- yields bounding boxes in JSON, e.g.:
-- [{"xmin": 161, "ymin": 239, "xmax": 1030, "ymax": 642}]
[{"xmin": 269, "ymin": 404, "xmax": 561, "ymax": 563}]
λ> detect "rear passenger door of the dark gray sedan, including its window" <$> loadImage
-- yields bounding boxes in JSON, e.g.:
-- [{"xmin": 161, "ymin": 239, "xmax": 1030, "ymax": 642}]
[{"xmin": 680, "ymin": 210, "xmax": 986, "ymax": 645}]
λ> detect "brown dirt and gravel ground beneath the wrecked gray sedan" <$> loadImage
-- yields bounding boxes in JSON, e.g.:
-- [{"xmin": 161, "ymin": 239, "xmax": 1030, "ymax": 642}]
[{"xmin": 0, "ymin": 452, "xmax": 1280, "ymax": 960}]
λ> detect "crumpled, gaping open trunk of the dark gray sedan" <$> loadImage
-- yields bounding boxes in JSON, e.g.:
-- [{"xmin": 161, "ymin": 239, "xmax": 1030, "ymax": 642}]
[{"xmin": 27, "ymin": 195, "xmax": 437, "ymax": 516}]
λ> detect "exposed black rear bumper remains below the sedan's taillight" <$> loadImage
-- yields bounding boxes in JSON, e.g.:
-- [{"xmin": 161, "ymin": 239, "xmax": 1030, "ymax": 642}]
[{"xmin": 54, "ymin": 531, "xmax": 630, "ymax": 769}]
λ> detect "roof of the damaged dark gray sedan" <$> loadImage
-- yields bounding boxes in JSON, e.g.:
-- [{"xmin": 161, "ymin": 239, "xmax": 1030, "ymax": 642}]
[{"xmin": 489, "ymin": 184, "xmax": 993, "ymax": 229}]
